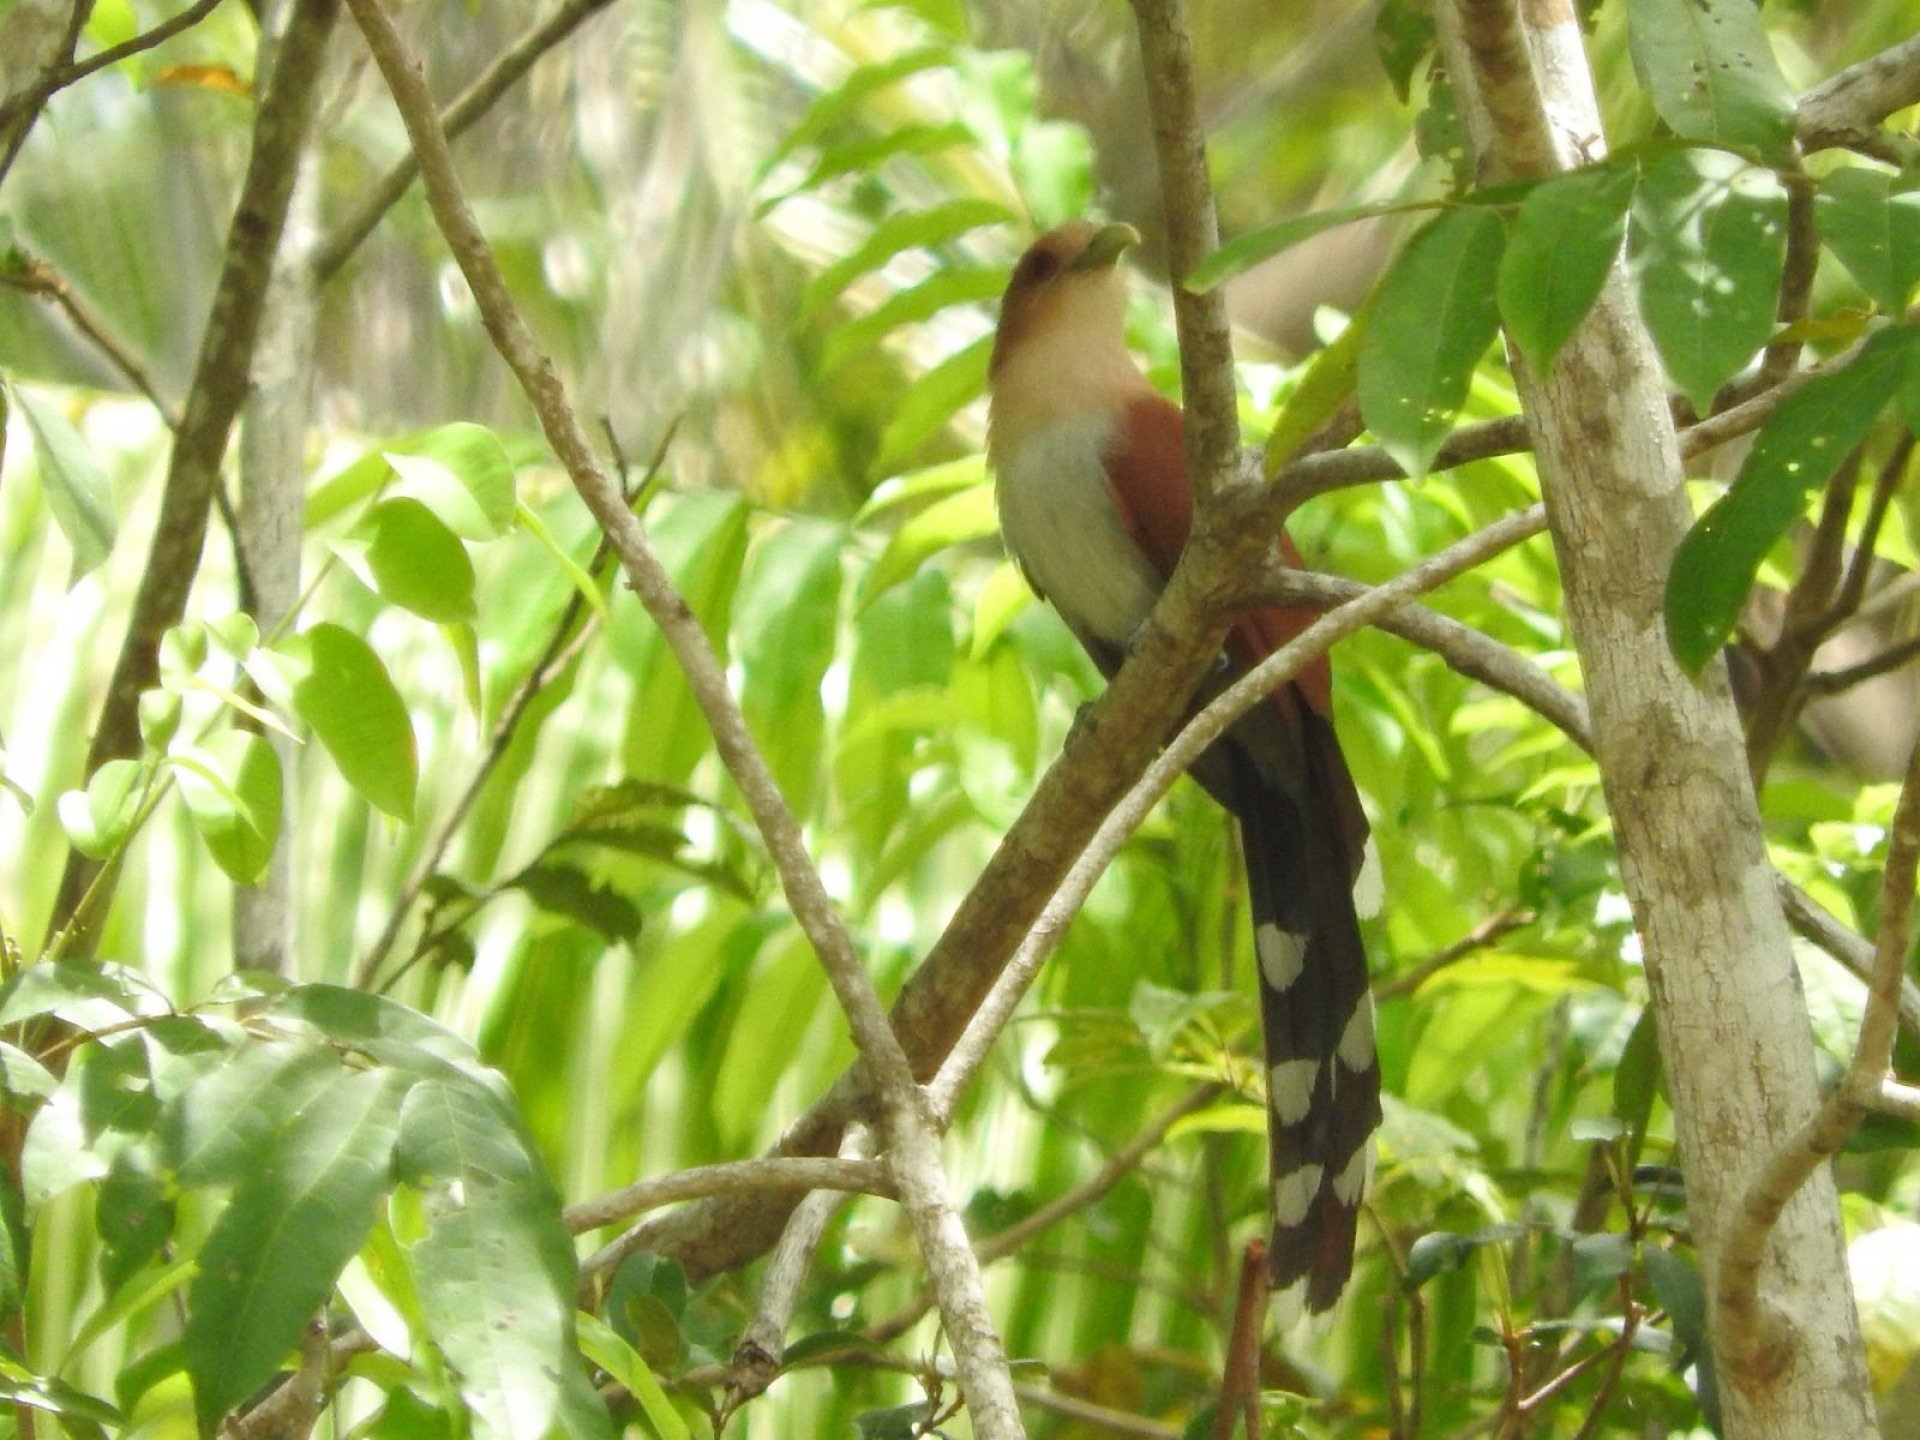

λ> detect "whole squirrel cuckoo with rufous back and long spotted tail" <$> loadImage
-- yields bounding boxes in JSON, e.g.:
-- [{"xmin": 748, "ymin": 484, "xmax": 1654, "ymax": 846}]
[{"xmin": 987, "ymin": 221, "xmax": 1380, "ymax": 1311}]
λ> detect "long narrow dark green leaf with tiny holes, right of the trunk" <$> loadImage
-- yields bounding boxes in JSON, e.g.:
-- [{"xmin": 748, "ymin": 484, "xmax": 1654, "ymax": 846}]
[{"xmin": 1667, "ymin": 326, "xmax": 1920, "ymax": 672}]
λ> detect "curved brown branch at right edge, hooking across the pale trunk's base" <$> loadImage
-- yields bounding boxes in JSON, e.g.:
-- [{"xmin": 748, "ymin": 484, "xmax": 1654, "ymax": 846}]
[{"xmin": 1715, "ymin": 745, "xmax": 1920, "ymax": 1369}]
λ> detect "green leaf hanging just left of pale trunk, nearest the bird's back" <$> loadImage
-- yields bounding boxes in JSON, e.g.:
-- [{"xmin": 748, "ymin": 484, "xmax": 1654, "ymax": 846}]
[{"xmin": 1359, "ymin": 209, "xmax": 1505, "ymax": 480}]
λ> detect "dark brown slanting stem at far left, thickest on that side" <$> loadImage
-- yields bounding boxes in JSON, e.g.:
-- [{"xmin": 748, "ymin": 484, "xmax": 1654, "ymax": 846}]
[{"xmin": 54, "ymin": 0, "xmax": 336, "ymax": 948}]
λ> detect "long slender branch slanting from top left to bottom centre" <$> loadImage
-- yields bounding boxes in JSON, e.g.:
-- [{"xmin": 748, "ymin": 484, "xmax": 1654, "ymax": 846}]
[{"xmin": 348, "ymin": 0, "xmax": 1023, "ymax": 1440}]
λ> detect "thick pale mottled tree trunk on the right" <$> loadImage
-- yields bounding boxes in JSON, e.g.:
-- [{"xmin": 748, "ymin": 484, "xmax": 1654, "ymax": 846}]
[{"xmin": 1434, "ymin": 0, "xmax": 1876, "ymax": 1440}]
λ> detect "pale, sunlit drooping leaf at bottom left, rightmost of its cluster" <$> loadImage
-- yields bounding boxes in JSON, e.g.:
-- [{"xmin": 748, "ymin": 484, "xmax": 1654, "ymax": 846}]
[{"xmin": 396, "ymin": 1081, "xmax": 609, "ymax": 1440}]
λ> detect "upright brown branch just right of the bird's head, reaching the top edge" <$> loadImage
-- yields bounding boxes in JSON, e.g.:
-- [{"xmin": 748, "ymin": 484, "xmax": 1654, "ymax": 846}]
[{"xmin": 1133, "ymin": 0, "xmax": 1240, "ymax": 505}]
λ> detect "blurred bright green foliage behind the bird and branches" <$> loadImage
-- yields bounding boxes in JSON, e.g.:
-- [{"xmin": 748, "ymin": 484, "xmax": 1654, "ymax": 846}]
[{"xmin": 0, "ymin": 0, "xmax": 1920, "ymax": 1436}]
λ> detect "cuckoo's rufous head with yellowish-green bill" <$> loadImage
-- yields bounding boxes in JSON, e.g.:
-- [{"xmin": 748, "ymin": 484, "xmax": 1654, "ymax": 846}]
[{"xmin": 993, "ymin": 221, "xmax": 1140, "ymax": 374}]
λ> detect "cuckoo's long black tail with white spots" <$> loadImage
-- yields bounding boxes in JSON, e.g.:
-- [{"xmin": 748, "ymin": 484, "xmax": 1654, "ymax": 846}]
[{"xmin": 1231, "ymin": 707, "xmax": 1380, "ymax": 1311}]
